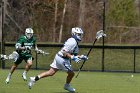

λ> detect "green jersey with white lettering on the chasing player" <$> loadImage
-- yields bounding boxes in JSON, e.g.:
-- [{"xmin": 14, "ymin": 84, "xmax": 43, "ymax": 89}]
[{"xmin": 16, "ymin": 35, "xmax": 36, "ymax": 56}]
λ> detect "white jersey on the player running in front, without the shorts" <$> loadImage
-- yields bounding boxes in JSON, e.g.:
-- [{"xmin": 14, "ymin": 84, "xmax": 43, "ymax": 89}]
[{"xmin": 58, "ymin": 37, "xmax": 79, "ymax": 56}]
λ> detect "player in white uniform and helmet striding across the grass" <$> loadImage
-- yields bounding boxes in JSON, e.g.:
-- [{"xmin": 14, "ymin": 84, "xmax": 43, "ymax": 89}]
[{"xmin": 28, "ymin": 27, "xmax": 88, "ymax": 92}]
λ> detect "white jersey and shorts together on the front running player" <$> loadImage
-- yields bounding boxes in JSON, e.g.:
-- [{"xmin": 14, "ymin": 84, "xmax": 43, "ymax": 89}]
[{"xmin": 50, "ymin": 38, "xmax": 79, "ymax": 71}]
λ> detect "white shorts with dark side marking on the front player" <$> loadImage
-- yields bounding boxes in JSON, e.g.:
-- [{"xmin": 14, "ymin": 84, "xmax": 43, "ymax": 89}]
[{"xmin": 50, "ymin": 54, "xmax": 72, "ymax": 71}]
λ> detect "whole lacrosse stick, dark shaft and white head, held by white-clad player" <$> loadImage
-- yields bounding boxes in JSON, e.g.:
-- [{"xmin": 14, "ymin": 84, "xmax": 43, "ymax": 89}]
[{"xmin": 76, "ymin": 30, "xmax": 106, "ymax": 78}]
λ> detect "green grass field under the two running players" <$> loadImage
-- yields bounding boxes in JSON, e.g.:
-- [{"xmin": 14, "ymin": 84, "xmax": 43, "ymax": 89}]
[{"xmin": 0, "ymin": 69, "xmax": 140, "ymax": 93}]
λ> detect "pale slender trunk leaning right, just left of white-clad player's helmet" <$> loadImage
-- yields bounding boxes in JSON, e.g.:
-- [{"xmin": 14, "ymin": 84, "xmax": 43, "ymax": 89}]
[{"xmin": 59, "ymin": 0, "xmax": 67, "ymax": 43}]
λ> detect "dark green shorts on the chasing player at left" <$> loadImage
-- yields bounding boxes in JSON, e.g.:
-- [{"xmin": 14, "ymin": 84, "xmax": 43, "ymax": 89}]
[{"xmin": 14, "ymin": 54, "xmax": 32, "ymax": 65}]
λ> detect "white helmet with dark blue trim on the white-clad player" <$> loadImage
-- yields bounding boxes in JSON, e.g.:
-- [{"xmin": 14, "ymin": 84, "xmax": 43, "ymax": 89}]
[{"xmin": 71, "ymin": 27, "xmax": 84, "ymax": 41}]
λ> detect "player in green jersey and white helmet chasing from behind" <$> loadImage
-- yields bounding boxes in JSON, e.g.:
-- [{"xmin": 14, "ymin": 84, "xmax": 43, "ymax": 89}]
[{"xmin": 1, "ymin": 28, "xmax": 47, "ymax": 84}]
